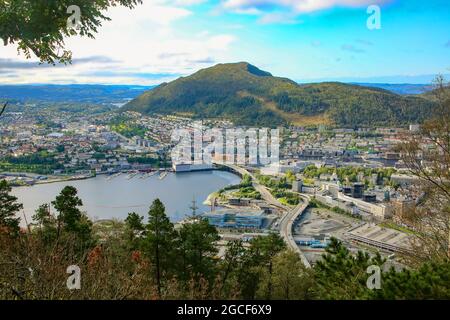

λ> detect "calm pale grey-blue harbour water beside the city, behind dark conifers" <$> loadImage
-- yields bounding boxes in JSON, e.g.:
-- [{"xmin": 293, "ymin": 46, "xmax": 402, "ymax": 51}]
[{"xmin": 12, "ymin": 171, "xmax": 240, "ymax": 223}]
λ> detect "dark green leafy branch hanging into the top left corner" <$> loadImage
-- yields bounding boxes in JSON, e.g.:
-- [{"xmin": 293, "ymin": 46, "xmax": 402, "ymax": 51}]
[{"xmin": 0, "ymin": 0, "xmax": 141, "ymax": 64}]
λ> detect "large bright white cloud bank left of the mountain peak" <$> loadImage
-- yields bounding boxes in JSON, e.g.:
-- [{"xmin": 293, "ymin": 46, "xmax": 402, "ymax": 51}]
[{"xmin": 0, "ymin": 0, "xmax": 237, "ymax": 84}]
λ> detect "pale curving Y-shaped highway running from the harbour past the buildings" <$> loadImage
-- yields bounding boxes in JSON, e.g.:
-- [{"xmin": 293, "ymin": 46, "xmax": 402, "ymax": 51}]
[{"xmin": 219, "ymin": 164, "xmax": 311, "ymax": 268}]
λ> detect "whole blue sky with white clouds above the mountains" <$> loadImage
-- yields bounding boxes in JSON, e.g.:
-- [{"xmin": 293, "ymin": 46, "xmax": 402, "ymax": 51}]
[{"xmin": 0, "ymin": 0, "xmax": 450, "ymax": 85}]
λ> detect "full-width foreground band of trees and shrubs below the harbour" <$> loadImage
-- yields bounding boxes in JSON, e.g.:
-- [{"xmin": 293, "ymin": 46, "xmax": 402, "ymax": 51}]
[{"xmin": 0, "ymin": 192, "xmax": 450, "ymax": 300}]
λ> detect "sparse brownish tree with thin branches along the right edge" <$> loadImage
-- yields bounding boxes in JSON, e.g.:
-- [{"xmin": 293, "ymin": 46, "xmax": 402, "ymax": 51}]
[{"xmin": 398, "ymin": 77, "xmax": 450, "ymax": 263}]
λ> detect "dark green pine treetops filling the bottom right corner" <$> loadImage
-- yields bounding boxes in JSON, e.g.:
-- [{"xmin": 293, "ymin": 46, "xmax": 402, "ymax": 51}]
[{"xmin": 312, "ymin": 238, "xmax": 450, "ymax": 300}]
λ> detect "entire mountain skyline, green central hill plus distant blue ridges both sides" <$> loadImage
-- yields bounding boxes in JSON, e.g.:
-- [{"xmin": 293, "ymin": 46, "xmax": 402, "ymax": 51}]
[{"xmin": 0, "ymin": 62, "xmax": 440, "ymax": 127}]
